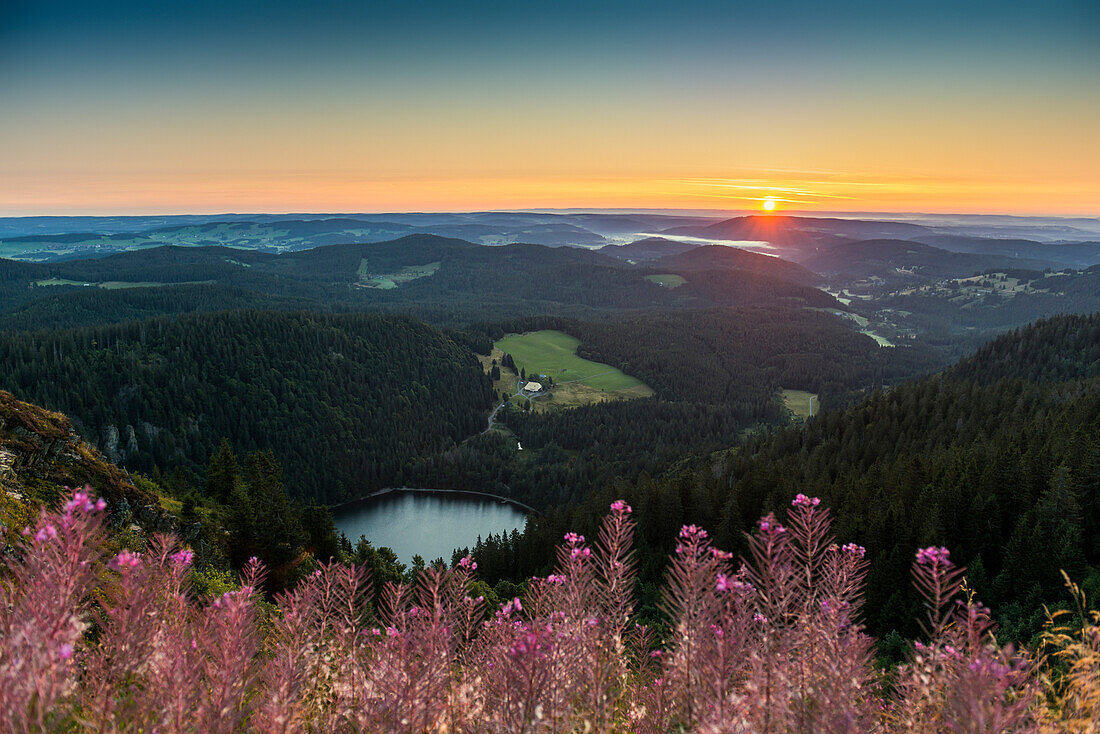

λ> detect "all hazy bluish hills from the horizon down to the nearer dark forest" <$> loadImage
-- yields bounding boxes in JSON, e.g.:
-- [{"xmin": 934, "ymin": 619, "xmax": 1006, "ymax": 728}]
[{"xmin": 0, "ymin": 211, "xmax": 1100, "ymax": 347}]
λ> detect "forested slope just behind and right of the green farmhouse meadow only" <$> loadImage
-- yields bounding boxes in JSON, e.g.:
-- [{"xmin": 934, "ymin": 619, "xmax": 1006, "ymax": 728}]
[{"xmin": 471, "ymin": 307, "xmax": 942, "ymax": 404}]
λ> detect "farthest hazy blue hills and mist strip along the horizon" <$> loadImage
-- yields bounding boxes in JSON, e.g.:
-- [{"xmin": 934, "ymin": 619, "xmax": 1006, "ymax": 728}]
[{"xmin": 0, "ymin": 211, "xmax": 1100, "ymax": 266}]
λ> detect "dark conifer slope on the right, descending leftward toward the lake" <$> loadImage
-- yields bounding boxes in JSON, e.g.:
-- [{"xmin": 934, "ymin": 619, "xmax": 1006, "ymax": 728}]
[{"xmin": 475, "ymin": 316, "xmax": 1100, "ymax": 640}]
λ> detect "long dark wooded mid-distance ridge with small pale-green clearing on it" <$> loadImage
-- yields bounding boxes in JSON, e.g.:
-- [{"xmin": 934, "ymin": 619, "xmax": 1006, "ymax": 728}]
[{"xmin": 0, "ymin": 234, "xmax": 838, "ymax": 328}]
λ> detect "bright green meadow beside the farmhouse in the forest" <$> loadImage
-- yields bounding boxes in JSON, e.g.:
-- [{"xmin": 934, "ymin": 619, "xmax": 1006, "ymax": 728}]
[{"xmin": 496, "ymin": 329, "xmax": 653, "ymax": 397}]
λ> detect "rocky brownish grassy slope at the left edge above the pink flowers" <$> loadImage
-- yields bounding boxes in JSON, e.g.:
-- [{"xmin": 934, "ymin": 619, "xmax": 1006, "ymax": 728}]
[{"xmin": 0, "ymin": 391, "xmax": 156, "ymax": 507}]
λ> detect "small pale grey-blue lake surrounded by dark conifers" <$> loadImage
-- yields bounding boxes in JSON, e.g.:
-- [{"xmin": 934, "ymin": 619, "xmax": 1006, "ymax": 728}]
[{"xmin": 332, "ymin": 492, "xmax": 527, "ymax": 563}]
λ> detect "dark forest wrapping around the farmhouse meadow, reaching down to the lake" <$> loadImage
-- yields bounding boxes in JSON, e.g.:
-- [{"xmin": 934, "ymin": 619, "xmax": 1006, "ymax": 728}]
[{"xmin": 404, "ymin": 308, "xmax": 935, "ymax": 510}]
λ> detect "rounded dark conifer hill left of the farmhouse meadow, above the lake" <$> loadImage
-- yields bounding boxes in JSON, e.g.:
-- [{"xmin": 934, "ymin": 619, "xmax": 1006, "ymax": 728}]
[{"xmin": 0, "ymin": 311, "xmax": 493, "ymax": 502}]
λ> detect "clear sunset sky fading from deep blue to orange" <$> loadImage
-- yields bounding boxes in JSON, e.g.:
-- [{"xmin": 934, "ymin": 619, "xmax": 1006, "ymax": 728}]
[{"xmin": 0, "ymin": 0, "xmax": 1100, "ymax": 216}]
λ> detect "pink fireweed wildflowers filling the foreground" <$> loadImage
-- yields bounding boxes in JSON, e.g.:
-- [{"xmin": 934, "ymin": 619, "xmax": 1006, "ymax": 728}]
[{"xmin": 0, "ymin": 491, "xmax": 1100, "ymax": 734}]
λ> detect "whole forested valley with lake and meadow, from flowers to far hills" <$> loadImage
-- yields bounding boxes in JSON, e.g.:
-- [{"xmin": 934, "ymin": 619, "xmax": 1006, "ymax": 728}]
[{"xmin": 0, "ymin": 212, "xmax": 1100, "ymax": 721}]
